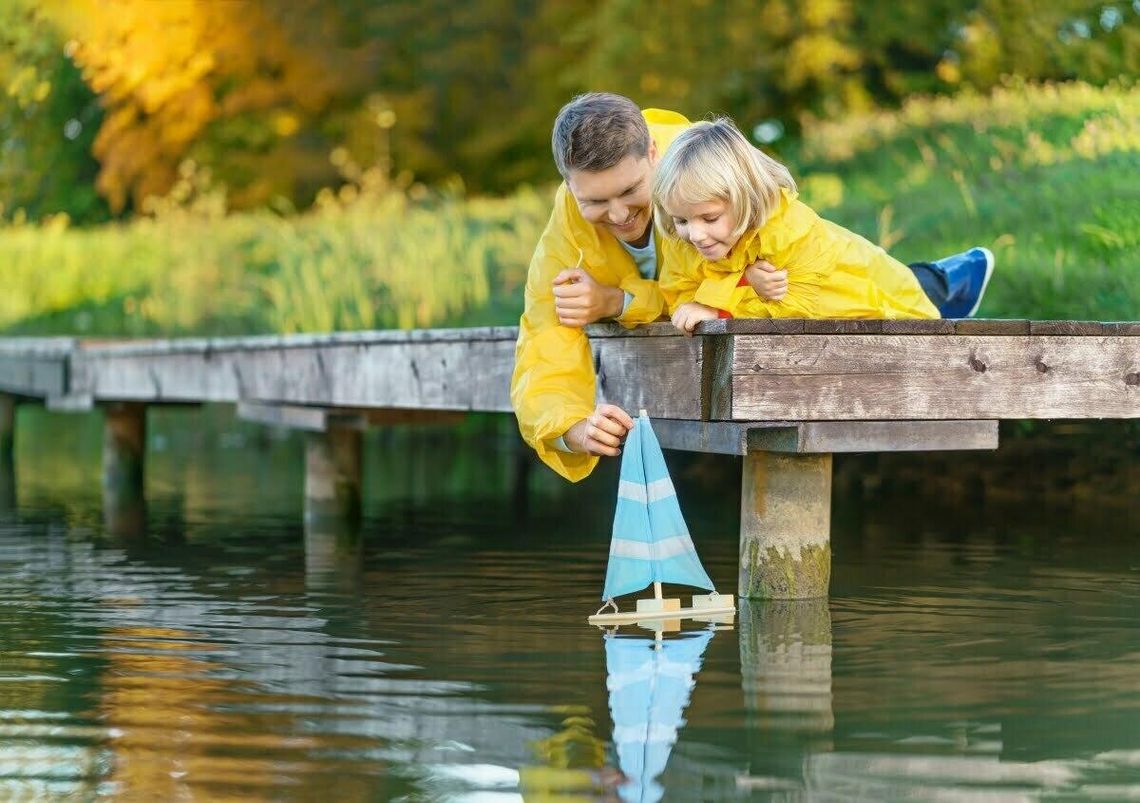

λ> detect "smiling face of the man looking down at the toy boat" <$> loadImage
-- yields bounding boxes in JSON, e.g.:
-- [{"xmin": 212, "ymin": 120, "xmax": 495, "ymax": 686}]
[{"xmin": 567, "ymin": 143, "xmax": 657, "ymax": 245}]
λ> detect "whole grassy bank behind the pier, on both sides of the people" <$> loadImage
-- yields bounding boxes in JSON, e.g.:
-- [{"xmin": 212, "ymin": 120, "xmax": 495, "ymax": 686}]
[{"xmin": 0, "ymin": 78, "xmax": 1140, "ymax": 335}]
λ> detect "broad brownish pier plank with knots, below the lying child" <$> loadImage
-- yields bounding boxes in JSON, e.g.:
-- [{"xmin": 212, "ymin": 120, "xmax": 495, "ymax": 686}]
[{"xmin": 719, "ymin": 335, "xmax": 1140, "ymax": 421}]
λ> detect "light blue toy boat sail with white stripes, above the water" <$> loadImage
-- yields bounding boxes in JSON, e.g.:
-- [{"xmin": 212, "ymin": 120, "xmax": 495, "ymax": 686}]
[{"xmin": 602, "ymin": 413, "xmax": 714, "ymax": 600}]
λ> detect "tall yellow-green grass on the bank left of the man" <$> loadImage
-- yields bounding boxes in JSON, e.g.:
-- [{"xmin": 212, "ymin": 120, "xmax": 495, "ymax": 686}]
[{"xmin": 0, "ymin": 166, "xmax": 548, "ymax": 335}]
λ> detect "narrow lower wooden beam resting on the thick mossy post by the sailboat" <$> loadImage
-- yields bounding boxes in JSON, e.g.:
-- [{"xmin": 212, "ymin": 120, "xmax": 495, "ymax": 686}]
[{"xmin": 653, "ymin": 419, "xmax": 998, "ymax": 455}]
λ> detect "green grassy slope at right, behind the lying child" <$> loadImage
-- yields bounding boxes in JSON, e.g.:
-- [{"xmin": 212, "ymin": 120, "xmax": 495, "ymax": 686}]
[{"xmin": 796, "ymin": 79, "xmax": 1140, "ymax": 321}]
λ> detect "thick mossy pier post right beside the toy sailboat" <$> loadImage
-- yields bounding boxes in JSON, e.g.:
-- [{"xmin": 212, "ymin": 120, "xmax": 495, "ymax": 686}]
[{"xmin": 738, "ymin": 452, "xmax": 831, "ymax": 599}]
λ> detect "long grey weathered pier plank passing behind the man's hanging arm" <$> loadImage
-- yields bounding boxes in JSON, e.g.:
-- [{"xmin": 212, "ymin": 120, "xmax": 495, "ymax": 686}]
[{"xmin": 73, "ymin": 335, "xmax": 701, "ymax": 417}]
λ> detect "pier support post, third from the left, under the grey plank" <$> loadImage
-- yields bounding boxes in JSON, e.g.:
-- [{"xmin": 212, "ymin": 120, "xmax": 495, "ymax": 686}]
[{"xmin": 304, "ymin": 424, "xmax": 361, "ymax": 522}]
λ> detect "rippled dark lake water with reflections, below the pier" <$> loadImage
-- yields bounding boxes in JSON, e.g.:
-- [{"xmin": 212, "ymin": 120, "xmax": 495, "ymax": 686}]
[{"xmin": 0, "ymin": 411, "xmax": 1140, "ymax": 801}]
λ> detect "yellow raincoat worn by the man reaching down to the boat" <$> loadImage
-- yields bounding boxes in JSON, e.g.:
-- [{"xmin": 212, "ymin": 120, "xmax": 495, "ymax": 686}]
[{"xmin": 511, "ymin": 108, "xmax": 690, "ymax": 482}]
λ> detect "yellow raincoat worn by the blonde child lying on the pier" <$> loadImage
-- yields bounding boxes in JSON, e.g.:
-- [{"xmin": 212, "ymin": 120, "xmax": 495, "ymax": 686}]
[{"xmin": 661, "ymin": 189, "xmax": 938, "ymax": 318}]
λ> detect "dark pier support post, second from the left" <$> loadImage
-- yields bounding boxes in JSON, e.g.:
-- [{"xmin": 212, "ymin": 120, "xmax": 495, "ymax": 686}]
[{"xmin": 103, "ymin": 402, "xmax": 146, "ymax": 535}]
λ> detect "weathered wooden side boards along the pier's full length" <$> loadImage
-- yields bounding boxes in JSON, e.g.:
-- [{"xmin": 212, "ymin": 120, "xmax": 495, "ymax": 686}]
[{"xmin": 0, "ymin": 319, "xmax": 1140, "ymax": 422}]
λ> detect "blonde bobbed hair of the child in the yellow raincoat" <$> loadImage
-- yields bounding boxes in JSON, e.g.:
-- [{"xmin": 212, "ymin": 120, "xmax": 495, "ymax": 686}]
[{"xmin": 653, "ymin": 117, "xmax": 796, "ymax": 238}]
